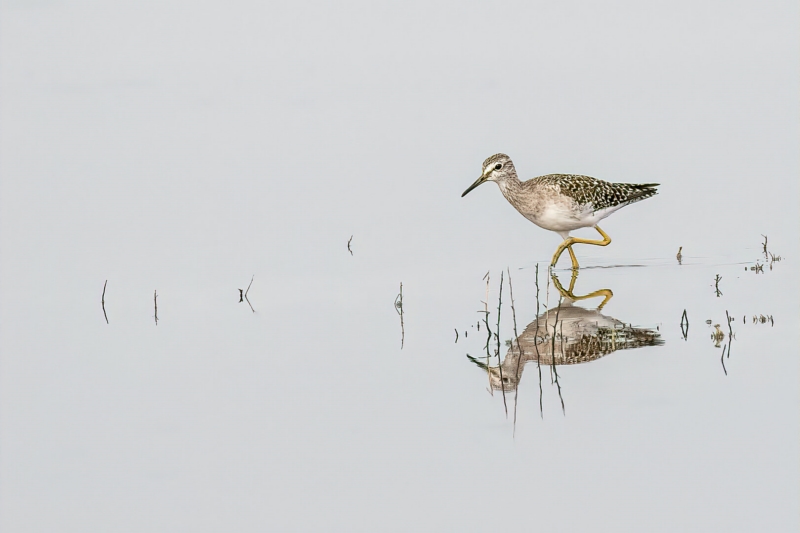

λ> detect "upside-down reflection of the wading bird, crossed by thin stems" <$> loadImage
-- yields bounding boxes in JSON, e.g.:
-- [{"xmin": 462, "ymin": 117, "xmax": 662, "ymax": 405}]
[{"xmin": 468, "ymin": 276, "xmax": 664, "ymax": 391}]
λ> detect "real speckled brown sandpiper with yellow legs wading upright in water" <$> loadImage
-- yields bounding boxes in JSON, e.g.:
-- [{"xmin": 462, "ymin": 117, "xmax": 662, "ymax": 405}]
[{"xmin": 461, "ymin": 154, "xmax": 658, "ymax": 268}]
